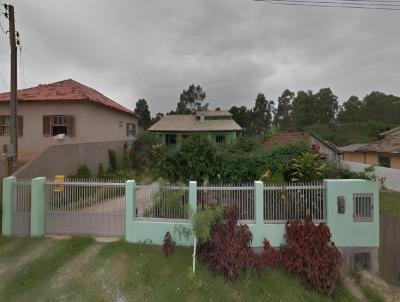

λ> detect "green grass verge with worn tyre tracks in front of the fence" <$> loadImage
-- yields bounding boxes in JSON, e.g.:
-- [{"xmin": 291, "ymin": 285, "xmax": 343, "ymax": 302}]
[{"xmin": 0, "ymin": 237, "xmax": 355, "ymax": 302}]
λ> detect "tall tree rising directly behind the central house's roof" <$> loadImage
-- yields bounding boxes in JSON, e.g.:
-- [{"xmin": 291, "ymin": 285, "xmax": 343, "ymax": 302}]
[{"xmin": 176, "ymin": 84, "xmax": 208, "ymax": 114}]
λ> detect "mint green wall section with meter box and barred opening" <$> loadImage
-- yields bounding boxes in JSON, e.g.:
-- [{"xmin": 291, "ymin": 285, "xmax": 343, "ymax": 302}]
[{"xmin": 325, "ymin": 179, "xmax": 379, "ymax": 247}]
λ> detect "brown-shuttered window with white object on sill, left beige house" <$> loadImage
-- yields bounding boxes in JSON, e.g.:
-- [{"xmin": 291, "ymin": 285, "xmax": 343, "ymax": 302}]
[{"xmin": 43, "ymin": 115, "xmax": 75, "ymax": 136}]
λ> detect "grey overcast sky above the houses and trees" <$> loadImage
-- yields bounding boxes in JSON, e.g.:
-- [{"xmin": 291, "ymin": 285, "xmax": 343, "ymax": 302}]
[{"xmin": 0, "ymin": 0, "xmax": 400, "ymax": 115}]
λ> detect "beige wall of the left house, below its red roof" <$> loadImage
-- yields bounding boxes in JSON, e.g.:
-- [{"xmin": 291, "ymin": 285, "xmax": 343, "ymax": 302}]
[{"xmin": 0, "ymin": 102, "xmax": 138, "ymax": 159}]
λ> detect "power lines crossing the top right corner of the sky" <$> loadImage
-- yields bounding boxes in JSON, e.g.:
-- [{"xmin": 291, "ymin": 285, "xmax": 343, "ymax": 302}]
[{"xmin": 253, "ymin": 0, "xmax": 400, "ymax": 11}]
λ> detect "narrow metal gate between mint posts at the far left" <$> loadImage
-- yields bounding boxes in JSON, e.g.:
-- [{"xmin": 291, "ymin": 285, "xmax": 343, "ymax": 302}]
[{"xmin": 12, "ymin": 179, "xmax": 31, "ymax": 236}]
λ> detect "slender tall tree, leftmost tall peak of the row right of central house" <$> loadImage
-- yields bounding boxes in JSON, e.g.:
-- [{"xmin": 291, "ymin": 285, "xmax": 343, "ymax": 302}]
[{"xmin": 252, "ymin": 93, "xmax": 274, "ymax": 134}]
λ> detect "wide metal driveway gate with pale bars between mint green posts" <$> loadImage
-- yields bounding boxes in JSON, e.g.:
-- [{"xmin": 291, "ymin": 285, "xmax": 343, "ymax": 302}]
[{"xmin": 45, "ymin": 180, "xmax": 125, "ymax": 237}]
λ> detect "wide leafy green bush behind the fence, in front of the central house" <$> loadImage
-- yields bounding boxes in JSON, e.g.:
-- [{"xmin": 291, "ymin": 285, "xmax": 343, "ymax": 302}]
[{"xmin": 158, "ymin": 136, "xmax": 309, "ymax": 183}]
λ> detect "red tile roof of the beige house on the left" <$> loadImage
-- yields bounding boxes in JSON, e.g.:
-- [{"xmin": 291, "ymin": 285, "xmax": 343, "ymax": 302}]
[{"xmin": 0, "ymin": 79, "xmax": 135, "ymax": 114}]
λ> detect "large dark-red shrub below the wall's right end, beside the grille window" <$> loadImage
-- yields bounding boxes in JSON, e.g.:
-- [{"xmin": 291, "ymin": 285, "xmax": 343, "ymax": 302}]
[{"xmin": 281, "ymin": 218, "xmax": 342, "ymax": 294}]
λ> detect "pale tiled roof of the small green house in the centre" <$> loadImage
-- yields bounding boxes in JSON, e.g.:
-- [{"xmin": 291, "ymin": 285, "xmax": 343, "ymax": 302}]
[{"xmin": 148, "ymin": 111, "xmax": 242, "ymax": 132}]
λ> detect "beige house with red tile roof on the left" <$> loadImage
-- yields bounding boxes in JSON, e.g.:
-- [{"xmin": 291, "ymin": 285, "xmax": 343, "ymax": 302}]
[{"xmin": 0, "ymin": 79, "xmax": 138, "ymax": 159}]
